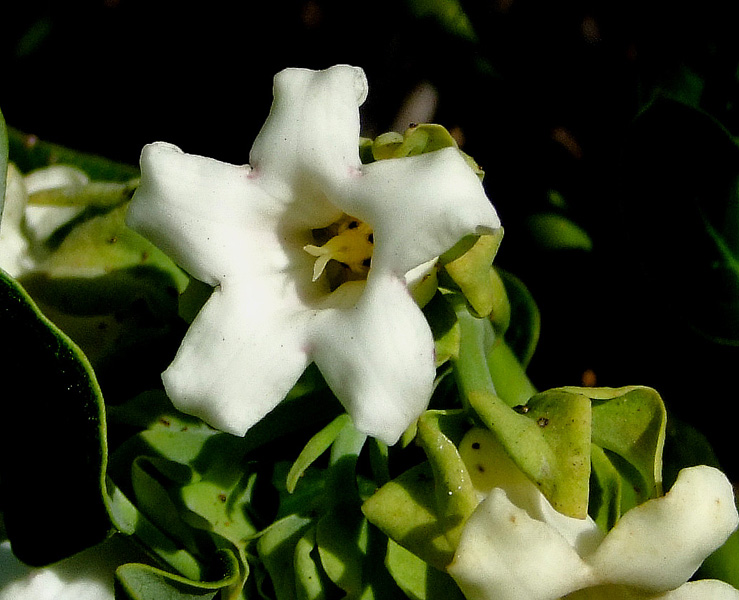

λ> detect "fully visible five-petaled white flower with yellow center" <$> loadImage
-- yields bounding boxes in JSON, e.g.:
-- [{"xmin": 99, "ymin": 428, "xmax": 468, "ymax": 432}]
[{"xmin": 128, "ymin": 65, "xmax": 500, "ymax": 444}]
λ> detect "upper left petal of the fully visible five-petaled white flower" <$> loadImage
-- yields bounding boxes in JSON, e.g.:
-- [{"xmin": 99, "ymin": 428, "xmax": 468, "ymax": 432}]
[{"xmin": 126, "ymin": 143, "xmax": 282, "ymax": 285}]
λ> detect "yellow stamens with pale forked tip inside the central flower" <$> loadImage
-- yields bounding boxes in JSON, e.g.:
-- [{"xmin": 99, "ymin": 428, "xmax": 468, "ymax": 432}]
[{"xmin": 303, "ymin": 215, "xmax": 374, "ymax": 281}]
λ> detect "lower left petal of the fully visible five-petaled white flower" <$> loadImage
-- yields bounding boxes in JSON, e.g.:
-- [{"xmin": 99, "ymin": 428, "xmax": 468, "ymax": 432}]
[{"xmin": 162, "ymin": 281, "xmax": 312, "ymax": 435}]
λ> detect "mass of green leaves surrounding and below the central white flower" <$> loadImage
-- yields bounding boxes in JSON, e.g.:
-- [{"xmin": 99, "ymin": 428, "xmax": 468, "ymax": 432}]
[{"xmin": 0, "ymin": 117, "xmax": 736, "ymax": 600}]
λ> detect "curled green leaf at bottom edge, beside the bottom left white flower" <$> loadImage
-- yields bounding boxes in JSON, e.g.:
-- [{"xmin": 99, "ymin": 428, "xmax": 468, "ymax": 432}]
[{"xmin": 116, "ymin": 551, "xmax": 241, "ymax": 600}]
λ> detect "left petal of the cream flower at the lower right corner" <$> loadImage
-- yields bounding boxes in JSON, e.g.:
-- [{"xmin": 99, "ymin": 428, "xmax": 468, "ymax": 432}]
[{"xmin": 447, "ymin": 488, "xmax": 592, "ymax": 600}]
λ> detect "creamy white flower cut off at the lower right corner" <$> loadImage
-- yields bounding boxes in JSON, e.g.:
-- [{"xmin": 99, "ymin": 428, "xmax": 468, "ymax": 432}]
[{"xmin": 448, "ymin": 431, "xmax": 739, "ymax": 600}]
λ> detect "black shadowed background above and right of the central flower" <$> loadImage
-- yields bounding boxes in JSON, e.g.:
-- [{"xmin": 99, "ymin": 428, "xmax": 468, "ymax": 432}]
[{"xmin": 0, "ymin": 0, "xmax": 739, "ymax": 479}]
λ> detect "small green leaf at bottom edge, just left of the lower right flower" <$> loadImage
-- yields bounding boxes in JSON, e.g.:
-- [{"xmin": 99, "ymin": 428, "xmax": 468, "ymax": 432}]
[{"xmin": 385, "ymin": 539, "xmax": 464, "ymax": 600}]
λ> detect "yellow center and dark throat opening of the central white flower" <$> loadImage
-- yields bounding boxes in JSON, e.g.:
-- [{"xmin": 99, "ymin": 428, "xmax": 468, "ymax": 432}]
[{"xmin": 303, "ymin": 215, "xmax": 374, "ymax": 291}]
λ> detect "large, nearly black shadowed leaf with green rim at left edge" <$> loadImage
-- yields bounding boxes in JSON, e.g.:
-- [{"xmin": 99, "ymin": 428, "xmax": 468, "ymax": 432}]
[{"xmin": 0, "ymin": 271, "xmax": 111, "ymax": 566}]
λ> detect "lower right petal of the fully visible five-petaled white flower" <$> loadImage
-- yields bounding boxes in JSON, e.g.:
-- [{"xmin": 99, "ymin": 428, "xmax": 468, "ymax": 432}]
[{"xmin": 312, "ymin": 271, "xmax": 436, "ymax": 444}]
